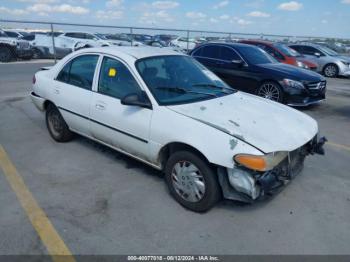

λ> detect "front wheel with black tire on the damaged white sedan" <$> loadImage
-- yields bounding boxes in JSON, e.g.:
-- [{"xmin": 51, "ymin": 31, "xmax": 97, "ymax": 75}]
[{"xmin": 165, "ymin": 151, "xmax": 221, "ymax": 212}]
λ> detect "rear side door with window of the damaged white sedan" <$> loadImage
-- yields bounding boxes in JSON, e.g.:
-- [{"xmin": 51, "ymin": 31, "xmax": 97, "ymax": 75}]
[{"xmin": 52, "ymin": 54, "xmax": 99, "ymax": 135}]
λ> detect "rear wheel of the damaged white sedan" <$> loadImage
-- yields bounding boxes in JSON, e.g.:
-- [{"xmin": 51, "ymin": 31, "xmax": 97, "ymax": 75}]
[{"xmin": 46, "ymin": 104, "xmax": 73, "ymax": 142}]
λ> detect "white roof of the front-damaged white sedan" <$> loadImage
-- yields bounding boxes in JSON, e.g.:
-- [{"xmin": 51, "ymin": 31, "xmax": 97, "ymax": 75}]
[{"xmin": 77, "ymin": 46, "xmax": 185, "ymax": 59}]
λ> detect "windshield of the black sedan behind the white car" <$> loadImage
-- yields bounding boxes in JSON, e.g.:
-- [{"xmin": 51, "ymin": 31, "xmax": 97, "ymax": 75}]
[{"xmin": 237, "ymin": 45, "xmax": 278, "ymax": 65}]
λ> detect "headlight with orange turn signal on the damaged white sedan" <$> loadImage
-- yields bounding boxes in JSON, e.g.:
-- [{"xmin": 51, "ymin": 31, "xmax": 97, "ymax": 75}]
[{"xmin": 234, "ymin": 151, "xmax": 288, "ymax": 171}]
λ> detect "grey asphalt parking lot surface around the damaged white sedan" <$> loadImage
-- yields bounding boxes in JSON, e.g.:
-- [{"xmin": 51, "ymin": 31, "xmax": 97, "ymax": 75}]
[{"xmin": 0, "ymin": 62, "xmax": 350, "ymax": 255}]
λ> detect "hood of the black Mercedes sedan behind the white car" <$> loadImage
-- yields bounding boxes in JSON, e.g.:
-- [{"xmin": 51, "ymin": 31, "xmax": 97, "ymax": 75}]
[{"xmin": 258, "ymin": 63, "xmax": 322, "ymax": 82}]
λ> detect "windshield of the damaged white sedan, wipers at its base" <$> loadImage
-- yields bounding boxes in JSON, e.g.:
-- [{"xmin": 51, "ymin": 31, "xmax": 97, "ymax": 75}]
[{"xmin": 136, "ymin": 55, "xmax": 235, "ymax": 105}]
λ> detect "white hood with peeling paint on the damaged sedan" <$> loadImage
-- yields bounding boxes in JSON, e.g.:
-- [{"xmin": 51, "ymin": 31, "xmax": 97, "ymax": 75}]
[{"xmin": 168, "ymin": 92, "xmax": 318, "ymax": 153}]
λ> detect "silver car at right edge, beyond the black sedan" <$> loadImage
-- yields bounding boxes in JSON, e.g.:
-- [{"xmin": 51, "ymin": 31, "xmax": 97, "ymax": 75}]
[{"xmin": 290, "ymin": 43, "xmax": 350, "ymax": 77}]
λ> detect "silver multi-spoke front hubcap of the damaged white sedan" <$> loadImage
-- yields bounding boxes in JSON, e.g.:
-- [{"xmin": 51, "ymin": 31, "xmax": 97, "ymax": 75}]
[{"xmin": 171, "ymin": 161, "xmax": 205, "ymax": 202}]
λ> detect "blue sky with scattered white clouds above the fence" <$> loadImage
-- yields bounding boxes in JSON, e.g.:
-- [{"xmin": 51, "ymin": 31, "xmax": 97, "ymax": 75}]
[{"xmin": 0, "ymin": 0, "xmax": 350, "ymax": 38}]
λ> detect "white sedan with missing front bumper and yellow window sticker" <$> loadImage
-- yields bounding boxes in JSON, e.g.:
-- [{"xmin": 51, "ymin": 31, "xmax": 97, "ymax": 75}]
[{"xmin": 31, "ymin": 47, "xmax": 324, "ymax": 212}]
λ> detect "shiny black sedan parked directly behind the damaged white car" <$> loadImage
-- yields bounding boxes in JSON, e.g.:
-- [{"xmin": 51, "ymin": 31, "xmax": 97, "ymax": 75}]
[{"xmin": 190, "ymin": 43, "xmax": 327, "ymax": 106}]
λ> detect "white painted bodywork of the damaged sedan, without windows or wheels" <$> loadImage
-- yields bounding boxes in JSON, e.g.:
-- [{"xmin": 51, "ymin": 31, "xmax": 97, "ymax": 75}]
[{"xmin": 32, "ymin": 47, "xmax": 318, "ymax": 169}]
